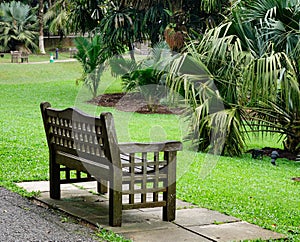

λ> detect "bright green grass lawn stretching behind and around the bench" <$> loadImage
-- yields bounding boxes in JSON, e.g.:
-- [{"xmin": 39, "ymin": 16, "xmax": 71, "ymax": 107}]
[{"xmin": 0, "ymin": 57, "xmax": 300, "ymax": 241}]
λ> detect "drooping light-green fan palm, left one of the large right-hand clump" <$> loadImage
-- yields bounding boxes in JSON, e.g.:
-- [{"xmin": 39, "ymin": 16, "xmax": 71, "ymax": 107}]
[{"xmin": 167, "ymin": 24, "xmax": 247, "ymax": 156}]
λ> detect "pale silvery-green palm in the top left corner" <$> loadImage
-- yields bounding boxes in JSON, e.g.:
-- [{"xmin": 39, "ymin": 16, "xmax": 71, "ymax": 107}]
[{"xmin": 0, "ymin": 1, "xmax": 38, "ymax": 51}]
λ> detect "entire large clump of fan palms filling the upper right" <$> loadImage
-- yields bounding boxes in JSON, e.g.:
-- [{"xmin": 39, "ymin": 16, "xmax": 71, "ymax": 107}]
[{"xmin": 169, "ymin": 0, "xmax": 300, "ymax": 155}]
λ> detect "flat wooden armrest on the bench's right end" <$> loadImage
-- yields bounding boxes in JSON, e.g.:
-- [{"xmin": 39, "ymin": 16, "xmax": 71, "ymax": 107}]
[{"xmin": 119, "ymin": 141, "xmax": 182, "ymax": 154}]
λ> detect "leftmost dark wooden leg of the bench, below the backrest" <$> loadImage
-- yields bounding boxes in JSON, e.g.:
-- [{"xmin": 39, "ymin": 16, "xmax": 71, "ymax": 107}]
[{"xmin": 49, "ymin": 154, "xmax": 60, "ymax": 199}]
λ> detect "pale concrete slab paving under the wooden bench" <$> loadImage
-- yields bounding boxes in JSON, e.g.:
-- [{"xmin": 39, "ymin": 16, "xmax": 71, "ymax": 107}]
[{"xmin": 18, "ymin": 181, "xmax": 284, "ymax": 242}]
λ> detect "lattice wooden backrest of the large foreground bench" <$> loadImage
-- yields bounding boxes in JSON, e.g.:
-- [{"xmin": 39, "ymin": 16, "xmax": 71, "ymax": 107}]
[{"xmin": 40, "ymin": 102, "xmax": 121, "ymax": 168}]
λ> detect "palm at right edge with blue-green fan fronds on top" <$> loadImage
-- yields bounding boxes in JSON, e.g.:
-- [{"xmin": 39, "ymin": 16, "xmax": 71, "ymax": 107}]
[{"xmin": 240, "ymin": 0, "xmax": 300, "ymax": 152}]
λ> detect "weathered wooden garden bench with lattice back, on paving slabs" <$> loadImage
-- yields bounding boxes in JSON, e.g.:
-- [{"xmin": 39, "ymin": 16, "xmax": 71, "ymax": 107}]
[{"xmin": 40, "ymin": 102, "xmax": 182, "ymax": 226}]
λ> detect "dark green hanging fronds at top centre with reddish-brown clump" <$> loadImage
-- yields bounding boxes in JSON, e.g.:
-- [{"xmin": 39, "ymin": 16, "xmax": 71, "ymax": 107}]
[{"xmin": 100, "ymin": 0, "xmax": 230, "ymax": 55}]
